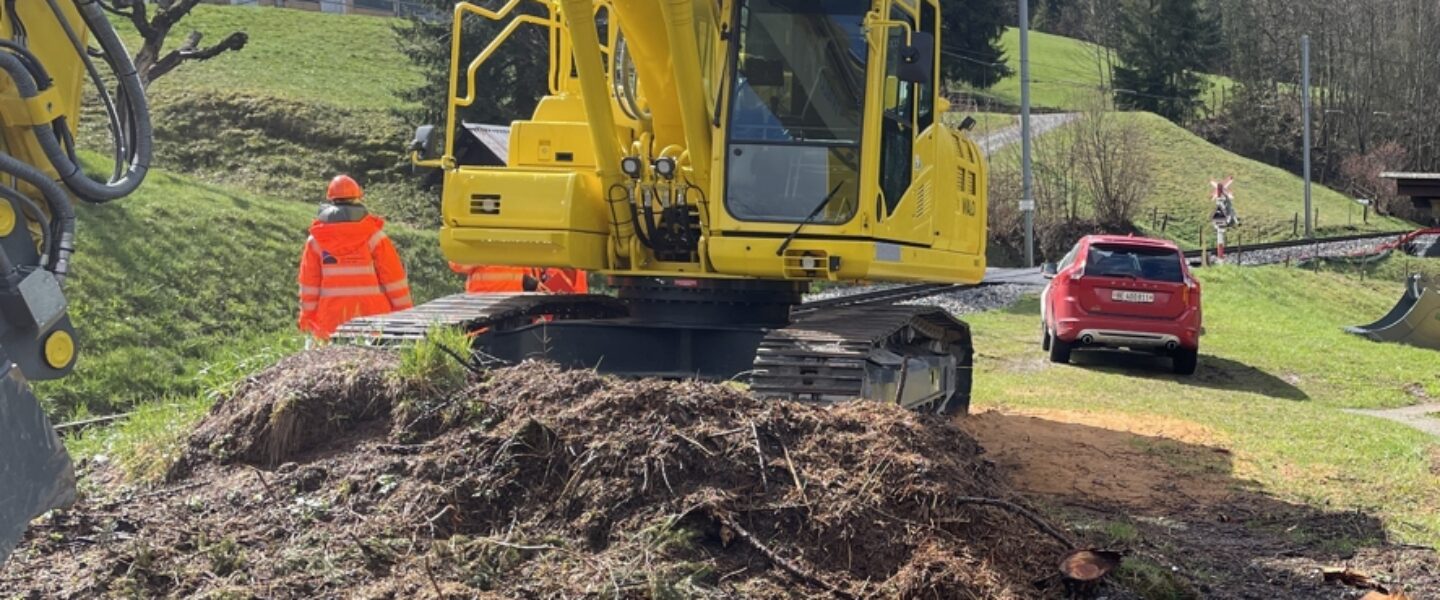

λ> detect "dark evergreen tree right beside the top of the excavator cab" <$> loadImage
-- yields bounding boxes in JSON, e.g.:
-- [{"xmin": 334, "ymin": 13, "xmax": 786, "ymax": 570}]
[{"xmin": 940, "ymin": 0, "xmax": 1015, "ymax": 89}]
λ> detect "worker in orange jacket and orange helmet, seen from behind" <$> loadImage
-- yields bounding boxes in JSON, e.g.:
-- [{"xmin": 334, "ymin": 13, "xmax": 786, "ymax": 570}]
[{"xmin": 300, "ymin": 176, "xmax": 415, "ymax": 340}]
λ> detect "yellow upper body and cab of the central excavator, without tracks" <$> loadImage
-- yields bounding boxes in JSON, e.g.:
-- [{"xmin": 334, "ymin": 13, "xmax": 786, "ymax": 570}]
[{"xmin": 422, "ymin": 0, "xmax": 986, "ymax": 282}]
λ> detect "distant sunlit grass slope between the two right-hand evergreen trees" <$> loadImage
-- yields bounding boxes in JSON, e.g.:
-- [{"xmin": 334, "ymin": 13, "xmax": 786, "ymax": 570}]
[{"xmin": 979, "ymin": 27, "xmax": 1234, "ymax": 111}]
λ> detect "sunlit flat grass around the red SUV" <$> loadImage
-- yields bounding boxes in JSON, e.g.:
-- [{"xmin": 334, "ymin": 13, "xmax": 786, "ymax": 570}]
[{"xmin": 969, "ymin": 268, "xmax": 1440, "ymax": 545}]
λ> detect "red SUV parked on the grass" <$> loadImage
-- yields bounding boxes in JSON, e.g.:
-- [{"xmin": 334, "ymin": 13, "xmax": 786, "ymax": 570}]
[{"xmin": 1040, "ymin": 236, "xmax": 1201, "ymax": 376}]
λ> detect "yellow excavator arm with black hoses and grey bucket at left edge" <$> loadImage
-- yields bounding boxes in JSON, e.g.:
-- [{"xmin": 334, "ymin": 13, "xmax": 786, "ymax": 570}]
[{"xmin": 0, "ymin": 0, "xmax": 151, "ymax": 563}]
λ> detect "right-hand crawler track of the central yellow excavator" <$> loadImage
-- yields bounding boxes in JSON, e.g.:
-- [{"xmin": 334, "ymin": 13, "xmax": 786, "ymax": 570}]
[{"xmin": 750, "ymin": 305, "xmax": 973, "ymax": 414}]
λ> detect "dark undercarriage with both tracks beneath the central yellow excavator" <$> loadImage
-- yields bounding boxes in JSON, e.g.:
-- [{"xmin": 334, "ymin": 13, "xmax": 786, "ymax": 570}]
[{"xmin": 336, "ymin": 278, "xmax": 972, "ymax": 413}]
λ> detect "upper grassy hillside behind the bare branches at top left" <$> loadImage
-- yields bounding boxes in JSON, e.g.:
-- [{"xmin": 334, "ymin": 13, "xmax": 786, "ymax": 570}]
[{"xmin": 82, "ymin": 4, "xmax": 426, "ymax": 215}]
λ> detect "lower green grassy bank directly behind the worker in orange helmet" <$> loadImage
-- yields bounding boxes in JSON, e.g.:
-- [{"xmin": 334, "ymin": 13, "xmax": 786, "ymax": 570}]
[{"xmin": 40, "ymin": 161, "xmax": 459, "ymax": 414}]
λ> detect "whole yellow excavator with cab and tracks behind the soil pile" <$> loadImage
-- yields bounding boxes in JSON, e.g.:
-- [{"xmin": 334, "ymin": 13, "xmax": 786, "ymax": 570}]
[{"xmin": 338, "ymin": 0, "xmax": 986, "ymax": 413}]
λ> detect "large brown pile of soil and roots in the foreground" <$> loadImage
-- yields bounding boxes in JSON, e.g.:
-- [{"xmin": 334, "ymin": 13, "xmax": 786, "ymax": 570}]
[{"xmin": 0, "ymin": 348, "xmax": 1066, "ymax": 599}]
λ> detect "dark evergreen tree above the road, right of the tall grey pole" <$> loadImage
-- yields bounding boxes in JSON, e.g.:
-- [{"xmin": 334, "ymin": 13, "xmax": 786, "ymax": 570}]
[{"xmin": 1115, "ymin": 0, "xmax": 1220, "ymax": 122}]
